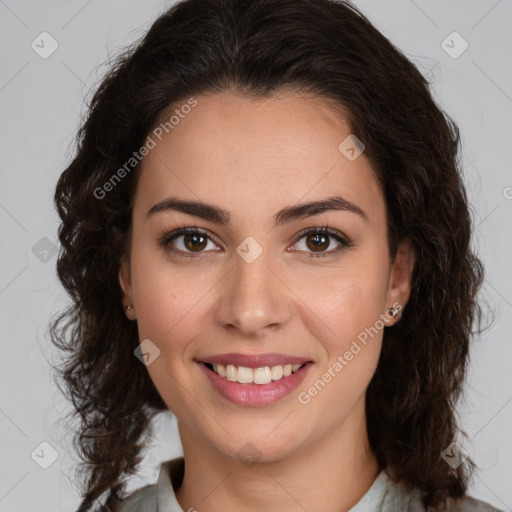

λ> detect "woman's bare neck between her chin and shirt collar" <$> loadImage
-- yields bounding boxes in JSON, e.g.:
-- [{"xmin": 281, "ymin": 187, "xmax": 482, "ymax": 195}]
[{"xmin": 175, "ymin": 401, "xmax": 380, "ymax": 512}]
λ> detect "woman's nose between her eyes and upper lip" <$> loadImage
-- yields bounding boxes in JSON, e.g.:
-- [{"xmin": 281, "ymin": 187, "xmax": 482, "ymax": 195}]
[{"xmin": 217, "ymin": 243, "xmax": 291, "ymax": 338}]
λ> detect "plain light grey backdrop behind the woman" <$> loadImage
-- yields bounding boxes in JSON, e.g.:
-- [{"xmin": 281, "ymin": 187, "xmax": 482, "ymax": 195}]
[{"xmin": 0, "ymin": 0, "xmax": 512, "ymax": 512}]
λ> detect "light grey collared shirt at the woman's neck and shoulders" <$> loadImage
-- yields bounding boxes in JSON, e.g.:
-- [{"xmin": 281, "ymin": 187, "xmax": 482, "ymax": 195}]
[{"xmin": 115, "ymin": 457, "xmax": 503, "ymax": 512}]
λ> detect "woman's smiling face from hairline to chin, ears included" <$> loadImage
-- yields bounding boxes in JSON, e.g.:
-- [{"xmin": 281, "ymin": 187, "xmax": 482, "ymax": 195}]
[{"xmin": 120, "ymin": 93, "xmax": 413, "ymax": 461}]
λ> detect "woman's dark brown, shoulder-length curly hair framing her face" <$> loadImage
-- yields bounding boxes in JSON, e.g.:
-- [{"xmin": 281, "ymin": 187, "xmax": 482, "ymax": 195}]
[{"xmin": 50, "ymin": 0, "xmax": 483, "ymax": 512}]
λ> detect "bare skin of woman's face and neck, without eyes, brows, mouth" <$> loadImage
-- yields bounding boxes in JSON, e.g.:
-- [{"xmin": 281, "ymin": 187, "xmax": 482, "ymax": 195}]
[{"xmin": 119, "ymin": 92, "xmax": 414, "ymax": 512}]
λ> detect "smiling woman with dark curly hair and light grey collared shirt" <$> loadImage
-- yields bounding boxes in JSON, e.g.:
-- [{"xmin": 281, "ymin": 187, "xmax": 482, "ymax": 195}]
[{"xmin": 52, "ymin": 0, "xmax": 496, "ymax": 512}]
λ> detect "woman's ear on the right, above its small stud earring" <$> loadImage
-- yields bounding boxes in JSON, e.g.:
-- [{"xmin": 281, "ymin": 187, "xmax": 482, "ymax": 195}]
[{"xmin": 387, "ymin": 240, "xmax": 416, "ymax": 311}]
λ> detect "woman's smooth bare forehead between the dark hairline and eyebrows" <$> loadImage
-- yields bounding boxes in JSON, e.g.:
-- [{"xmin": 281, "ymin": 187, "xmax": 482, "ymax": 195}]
[{"xmin": 135, "ymin": 92, "xmax": 384, "ymax": 228}]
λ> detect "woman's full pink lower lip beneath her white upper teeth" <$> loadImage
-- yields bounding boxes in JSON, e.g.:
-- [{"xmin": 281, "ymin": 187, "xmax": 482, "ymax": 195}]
[{"xmin": 199, "ymin": 363, "xmax": 313, "ymax": 405}]
